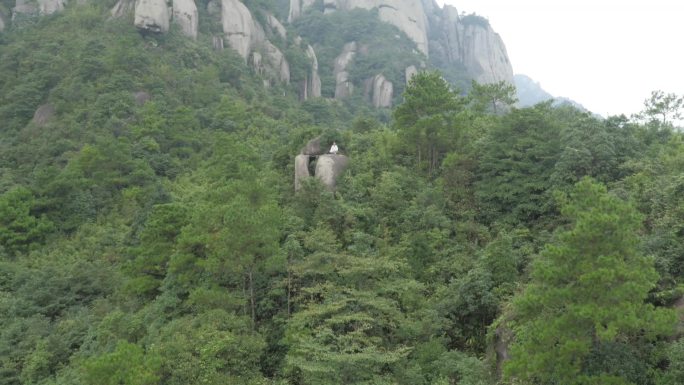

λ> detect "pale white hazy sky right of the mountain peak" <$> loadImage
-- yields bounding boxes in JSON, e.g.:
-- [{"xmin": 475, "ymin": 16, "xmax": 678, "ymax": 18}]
[{"xmin": 437, "ymin": 0, "xmax": 684, "ymax": 116}]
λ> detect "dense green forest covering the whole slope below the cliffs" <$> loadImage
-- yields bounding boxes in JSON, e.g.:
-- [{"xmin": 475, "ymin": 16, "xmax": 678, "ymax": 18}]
[{"xmin": 0, "ymin": 4, "xmax": 684, "ymax": 385}]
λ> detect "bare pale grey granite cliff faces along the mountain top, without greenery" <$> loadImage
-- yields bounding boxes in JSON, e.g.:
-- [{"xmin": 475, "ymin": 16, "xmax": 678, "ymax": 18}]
[{"xmin": 0, "ymin": 0, "xmax": 513, "ymax": 103}]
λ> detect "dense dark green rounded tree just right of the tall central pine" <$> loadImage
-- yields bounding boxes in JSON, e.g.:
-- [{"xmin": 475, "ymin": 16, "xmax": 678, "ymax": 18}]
[{"xmin": 475, "ymin": 104, "xmax": 560, "ymax": 224}]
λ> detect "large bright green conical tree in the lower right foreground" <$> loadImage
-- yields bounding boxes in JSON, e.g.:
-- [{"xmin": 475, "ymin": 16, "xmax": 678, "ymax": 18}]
[{"xmin": 506, "ymin": 179, "xmax": 674, "ymax": 384}]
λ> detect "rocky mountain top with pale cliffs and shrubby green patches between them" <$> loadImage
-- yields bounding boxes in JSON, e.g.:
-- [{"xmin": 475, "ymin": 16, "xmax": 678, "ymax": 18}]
[{"xmin": 0, "ymin": 0, "xmax": 513, "ymax": 107}]
